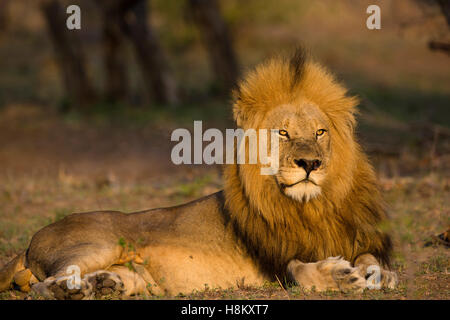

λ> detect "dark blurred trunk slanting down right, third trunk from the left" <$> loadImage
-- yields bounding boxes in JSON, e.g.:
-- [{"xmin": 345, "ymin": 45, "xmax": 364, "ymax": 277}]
[{"xmin": 123, "ymin": 1, "xmax": 178, "ymax": 105}]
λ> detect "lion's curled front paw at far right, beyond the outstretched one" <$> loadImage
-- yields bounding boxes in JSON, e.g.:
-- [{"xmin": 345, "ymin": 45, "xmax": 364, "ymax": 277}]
[{"xmin": 354, "ymin": 253, "xmax": 398, "ymax": 289}]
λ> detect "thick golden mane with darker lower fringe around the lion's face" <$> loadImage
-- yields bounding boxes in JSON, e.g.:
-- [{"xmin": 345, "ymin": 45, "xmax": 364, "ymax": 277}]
[{"xmin": 224, "ymin": 51, "xmax": 391, "ymax": 277}]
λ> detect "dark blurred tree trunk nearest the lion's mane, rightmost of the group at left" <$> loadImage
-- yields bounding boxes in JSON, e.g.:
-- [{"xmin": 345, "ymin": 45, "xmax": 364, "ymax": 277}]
[{"xmin": 189, "ymin": 0, "xmax": 239, "ymax": 90}]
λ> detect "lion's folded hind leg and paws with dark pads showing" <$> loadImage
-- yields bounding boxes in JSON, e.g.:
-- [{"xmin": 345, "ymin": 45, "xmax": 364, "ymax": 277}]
[{"xmin": 27, "ymin": 242, "xmax": 160, "ymax": 299}]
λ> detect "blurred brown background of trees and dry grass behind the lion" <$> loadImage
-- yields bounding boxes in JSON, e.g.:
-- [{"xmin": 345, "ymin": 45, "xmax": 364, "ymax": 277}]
[{"xmin": 0, "ymin": 0, "xmax": 450, "ymax": 298}]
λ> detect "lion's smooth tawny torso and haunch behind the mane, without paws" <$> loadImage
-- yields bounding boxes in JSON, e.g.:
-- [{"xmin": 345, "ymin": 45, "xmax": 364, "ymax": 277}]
[{"xmin": 16, "ymin": 192, "xmax": 263, "ymax": 294}]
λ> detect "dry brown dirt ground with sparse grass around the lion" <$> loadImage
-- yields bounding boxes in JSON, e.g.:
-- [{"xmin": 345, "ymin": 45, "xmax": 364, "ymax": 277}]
[{"xmin": 0, "ymin": 105, "xmax": 450, "ymax": 299}]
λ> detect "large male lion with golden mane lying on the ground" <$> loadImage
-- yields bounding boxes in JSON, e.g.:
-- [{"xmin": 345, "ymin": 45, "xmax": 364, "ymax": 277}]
[{"xmin": 0, "ymin": 50, "xmax": 397, "ymax": 299}]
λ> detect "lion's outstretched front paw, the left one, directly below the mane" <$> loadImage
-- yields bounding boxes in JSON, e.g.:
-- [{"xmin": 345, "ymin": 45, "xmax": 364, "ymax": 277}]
[{"xmin": 287, "ymin": 257, "xmax": 366, "ymax": 291}]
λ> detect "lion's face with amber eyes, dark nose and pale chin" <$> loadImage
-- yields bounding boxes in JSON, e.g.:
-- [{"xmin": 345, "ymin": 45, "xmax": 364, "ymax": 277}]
[{"xmin": 266, "ymin": 101, "xmax": 331, "ymax": 201}]
